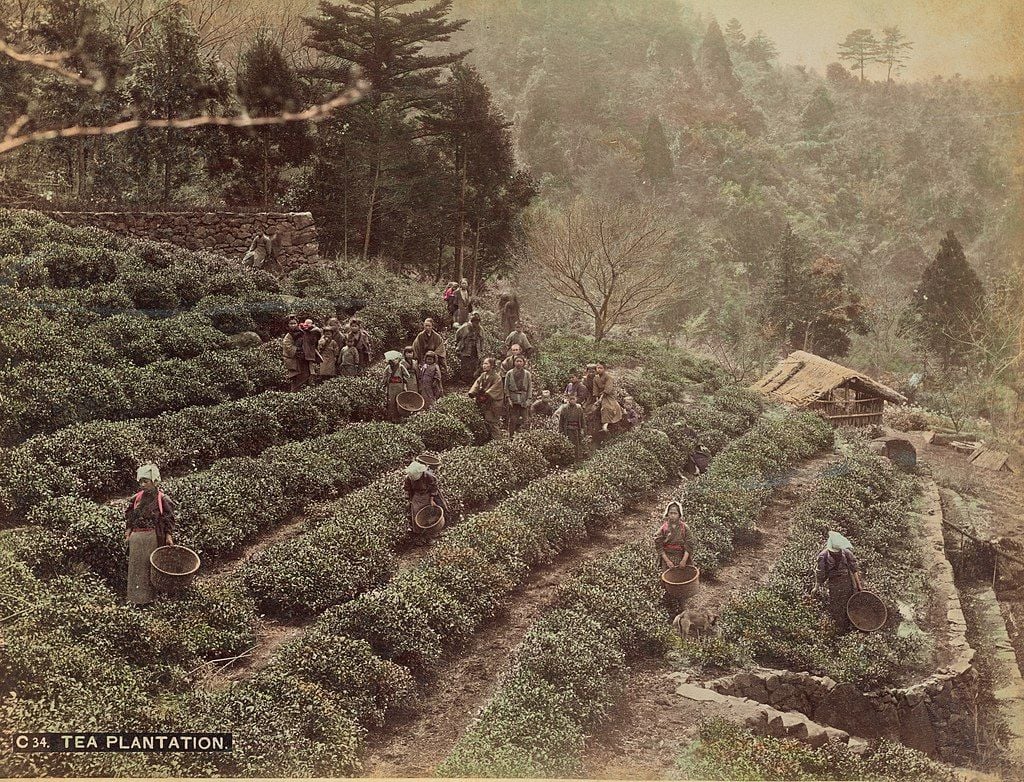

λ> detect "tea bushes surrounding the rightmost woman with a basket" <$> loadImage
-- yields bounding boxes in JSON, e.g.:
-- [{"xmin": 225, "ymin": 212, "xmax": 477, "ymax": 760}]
[{"xmin": 687, "ymin": 446, "xmax": 927, "ymax": 688}]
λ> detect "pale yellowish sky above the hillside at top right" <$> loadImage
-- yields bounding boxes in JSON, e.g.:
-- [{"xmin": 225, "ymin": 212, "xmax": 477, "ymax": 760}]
[{"xmin": 688, "ymin": 0, "xmax": 1024, "ymax": 80}]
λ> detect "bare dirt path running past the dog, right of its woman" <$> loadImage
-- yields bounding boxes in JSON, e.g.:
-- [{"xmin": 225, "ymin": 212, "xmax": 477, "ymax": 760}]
[{"xmin": 584, "ymin": 453, "xmax": 841, "ymax": 779}]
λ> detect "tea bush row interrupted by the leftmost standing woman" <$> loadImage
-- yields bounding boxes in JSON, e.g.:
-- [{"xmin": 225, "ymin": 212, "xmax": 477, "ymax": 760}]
[{"xmin": 12, "ymin": 403, "xmax": 483, "ymax": 584}]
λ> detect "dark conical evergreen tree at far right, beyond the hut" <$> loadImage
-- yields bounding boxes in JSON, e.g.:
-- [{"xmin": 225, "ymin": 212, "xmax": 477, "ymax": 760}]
[{"xmin": 907, "ymin": 231, "xmax": 985, "ymax": 368}]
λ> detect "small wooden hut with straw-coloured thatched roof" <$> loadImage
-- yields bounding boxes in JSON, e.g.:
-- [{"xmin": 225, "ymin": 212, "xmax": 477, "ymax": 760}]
[{"xmin": 752, "ymin": 350, "xmax": 906, "ymax": 426}]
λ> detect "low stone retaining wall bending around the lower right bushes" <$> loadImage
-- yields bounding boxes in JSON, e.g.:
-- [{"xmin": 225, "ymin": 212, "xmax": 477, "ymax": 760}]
[{"xmin": 703, "ymin": 481, "xmax": 978, "ymax": 763}]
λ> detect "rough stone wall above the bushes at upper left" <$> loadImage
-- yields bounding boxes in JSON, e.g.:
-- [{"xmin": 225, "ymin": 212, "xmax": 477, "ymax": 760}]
[{"xmin": 46, "ymin": 212, "xmax": 319, "ymax": 270}]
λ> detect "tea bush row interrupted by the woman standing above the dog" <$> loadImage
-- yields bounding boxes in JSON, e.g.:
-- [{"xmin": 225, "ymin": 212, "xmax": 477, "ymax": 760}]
[{"xmin": 438, "ymin": 403, "xmax": 831, "ymax": 777}]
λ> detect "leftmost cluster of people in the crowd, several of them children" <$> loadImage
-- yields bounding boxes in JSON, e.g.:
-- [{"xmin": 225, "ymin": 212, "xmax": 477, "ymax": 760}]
[{"xmin": 281, "ymin": 315, "xmax": 373, "ymax": 391}]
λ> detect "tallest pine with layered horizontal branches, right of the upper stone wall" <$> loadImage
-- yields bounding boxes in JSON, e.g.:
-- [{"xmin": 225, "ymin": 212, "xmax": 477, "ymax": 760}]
[{"xmin": 305, "ymin": 0, "xmax": 466, "ymax": 257}]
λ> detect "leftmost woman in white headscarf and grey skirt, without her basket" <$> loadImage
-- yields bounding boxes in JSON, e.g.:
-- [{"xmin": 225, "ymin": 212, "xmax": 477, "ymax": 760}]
[{"xmin": 125, "ymin": 465, "xmax": 174, "ymax": 606}]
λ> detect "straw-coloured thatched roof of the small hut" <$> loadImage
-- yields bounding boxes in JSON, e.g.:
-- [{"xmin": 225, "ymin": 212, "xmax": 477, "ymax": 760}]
[{"xmin": 751, "ymin": 350, "xmax": 906, "ymax": 407}]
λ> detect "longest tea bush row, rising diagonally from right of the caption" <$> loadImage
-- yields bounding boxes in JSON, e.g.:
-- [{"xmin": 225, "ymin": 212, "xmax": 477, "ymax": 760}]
[{"xmin": 188, "ymin": 392, "xmax": 760, "ymax": 775}]
